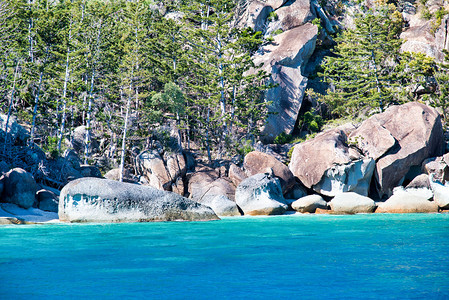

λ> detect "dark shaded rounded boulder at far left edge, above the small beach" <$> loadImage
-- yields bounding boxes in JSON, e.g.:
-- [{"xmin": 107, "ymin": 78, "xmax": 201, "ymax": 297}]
[{"xmin": 1, "ymin": 168, "xmax": 38, "ymax": 208}]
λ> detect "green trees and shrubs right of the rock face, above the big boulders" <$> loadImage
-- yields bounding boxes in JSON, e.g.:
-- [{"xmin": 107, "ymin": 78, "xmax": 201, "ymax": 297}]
[{"xmin": 320, "ymin": 0, "xmax": 449, "ymax": 122}]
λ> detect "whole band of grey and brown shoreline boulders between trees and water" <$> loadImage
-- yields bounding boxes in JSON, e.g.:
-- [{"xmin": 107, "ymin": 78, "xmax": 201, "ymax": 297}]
[{"xmin": 0, "ymin": 102, "xmax": 449, "ymax": 224}]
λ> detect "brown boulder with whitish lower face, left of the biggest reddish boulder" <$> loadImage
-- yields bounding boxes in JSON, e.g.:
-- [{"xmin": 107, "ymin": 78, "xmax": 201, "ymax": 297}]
[{"xmin": 289, "ymin": 128, "xmax": 374, "ymax": 196}]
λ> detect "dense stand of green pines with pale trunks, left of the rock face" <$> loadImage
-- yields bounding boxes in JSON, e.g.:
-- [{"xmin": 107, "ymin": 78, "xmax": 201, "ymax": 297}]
[{"xmin": 0, "ymin": 0, "xmax": 269, "ymax": 171}]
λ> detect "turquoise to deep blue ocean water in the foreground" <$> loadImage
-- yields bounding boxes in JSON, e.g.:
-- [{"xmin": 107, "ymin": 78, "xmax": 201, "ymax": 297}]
[{"xmin": 0, "ymin": 214, "xmax": 449, "ymax": 299}]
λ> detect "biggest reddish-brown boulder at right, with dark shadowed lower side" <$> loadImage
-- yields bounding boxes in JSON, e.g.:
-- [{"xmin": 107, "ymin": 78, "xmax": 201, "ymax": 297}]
[{"xmin": 349, "ymin": 102, "xmax": 444, "ymax": 197}]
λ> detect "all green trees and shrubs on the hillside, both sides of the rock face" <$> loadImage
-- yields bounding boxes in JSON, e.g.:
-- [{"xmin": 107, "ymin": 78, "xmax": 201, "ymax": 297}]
[{"xmin": 0, "ymin": 0, "xmax": 449, "ymax": 178}]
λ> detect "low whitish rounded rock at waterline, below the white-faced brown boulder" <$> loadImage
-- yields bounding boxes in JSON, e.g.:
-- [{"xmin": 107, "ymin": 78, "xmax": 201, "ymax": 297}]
[{"xmin": 329, "ymin": 192, "xmax": 376, "ymax": 214}]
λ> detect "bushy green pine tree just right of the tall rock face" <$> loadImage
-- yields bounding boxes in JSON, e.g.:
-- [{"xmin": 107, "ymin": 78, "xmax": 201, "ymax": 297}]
[{"xmin": 321, "ymin": 3, "xmax": 402, "ymax": 116}]
